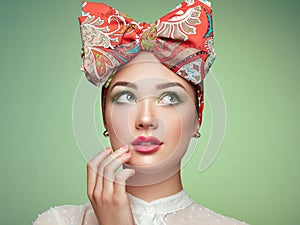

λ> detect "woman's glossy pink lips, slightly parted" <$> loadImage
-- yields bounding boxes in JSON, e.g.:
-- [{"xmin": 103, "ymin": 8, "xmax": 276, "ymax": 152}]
[{"xmin": 131, "ymin": 136, "xmax": 162, "ymax": 153}]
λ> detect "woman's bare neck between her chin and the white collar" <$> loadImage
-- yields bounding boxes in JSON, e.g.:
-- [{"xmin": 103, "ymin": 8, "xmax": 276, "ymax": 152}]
[{"xmin": 126, "ymin": 167, "xmax": 182, "ymax": 202}]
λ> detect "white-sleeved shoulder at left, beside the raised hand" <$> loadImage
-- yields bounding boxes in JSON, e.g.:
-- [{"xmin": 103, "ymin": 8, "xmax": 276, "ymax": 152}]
[{"xmin": 32, "ymin": 204, "xmax": 89, "ymax": 225}]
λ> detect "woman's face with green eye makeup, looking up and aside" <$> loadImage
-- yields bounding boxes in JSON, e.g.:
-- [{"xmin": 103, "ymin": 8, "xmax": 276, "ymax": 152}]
[{"xmin": 105, "ymin": 52, "xmax": 198, "ymax": 167}]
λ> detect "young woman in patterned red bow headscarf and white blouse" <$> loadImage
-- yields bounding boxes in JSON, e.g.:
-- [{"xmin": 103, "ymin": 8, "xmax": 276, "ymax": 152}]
[{"xmin": 34, "ymin": 0, "xmax": 248, "ymax": 225}]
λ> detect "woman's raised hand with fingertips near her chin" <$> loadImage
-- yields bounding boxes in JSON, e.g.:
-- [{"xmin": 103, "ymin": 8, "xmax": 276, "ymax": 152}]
[{"xmin": 87, "ymin": 146, "xmax": 134, "ymax": 225}]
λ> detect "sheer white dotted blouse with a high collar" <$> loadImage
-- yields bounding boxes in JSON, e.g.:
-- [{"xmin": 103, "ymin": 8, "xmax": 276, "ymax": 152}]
[{"xmin": 32, "ymin": 190, "xmax": 246, "ymax": 225}]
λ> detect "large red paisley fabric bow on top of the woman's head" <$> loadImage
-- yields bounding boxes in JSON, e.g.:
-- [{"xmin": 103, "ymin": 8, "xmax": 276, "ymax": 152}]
[{"xmin": 79, "ymin": 0, "xmax": 215, "ymax": 86}]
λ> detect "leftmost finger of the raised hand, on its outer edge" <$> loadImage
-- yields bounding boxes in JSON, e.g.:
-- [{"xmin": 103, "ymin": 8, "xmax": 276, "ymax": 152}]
[{"xmin": 87, "ymin": 148, "xmax": 112, "ymax": 199}]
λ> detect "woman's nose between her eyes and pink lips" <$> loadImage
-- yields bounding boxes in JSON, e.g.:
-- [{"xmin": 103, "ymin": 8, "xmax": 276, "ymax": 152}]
[{"xmin": 135, "ymin": 98, "xmax": 158, "ymax": 130}]
